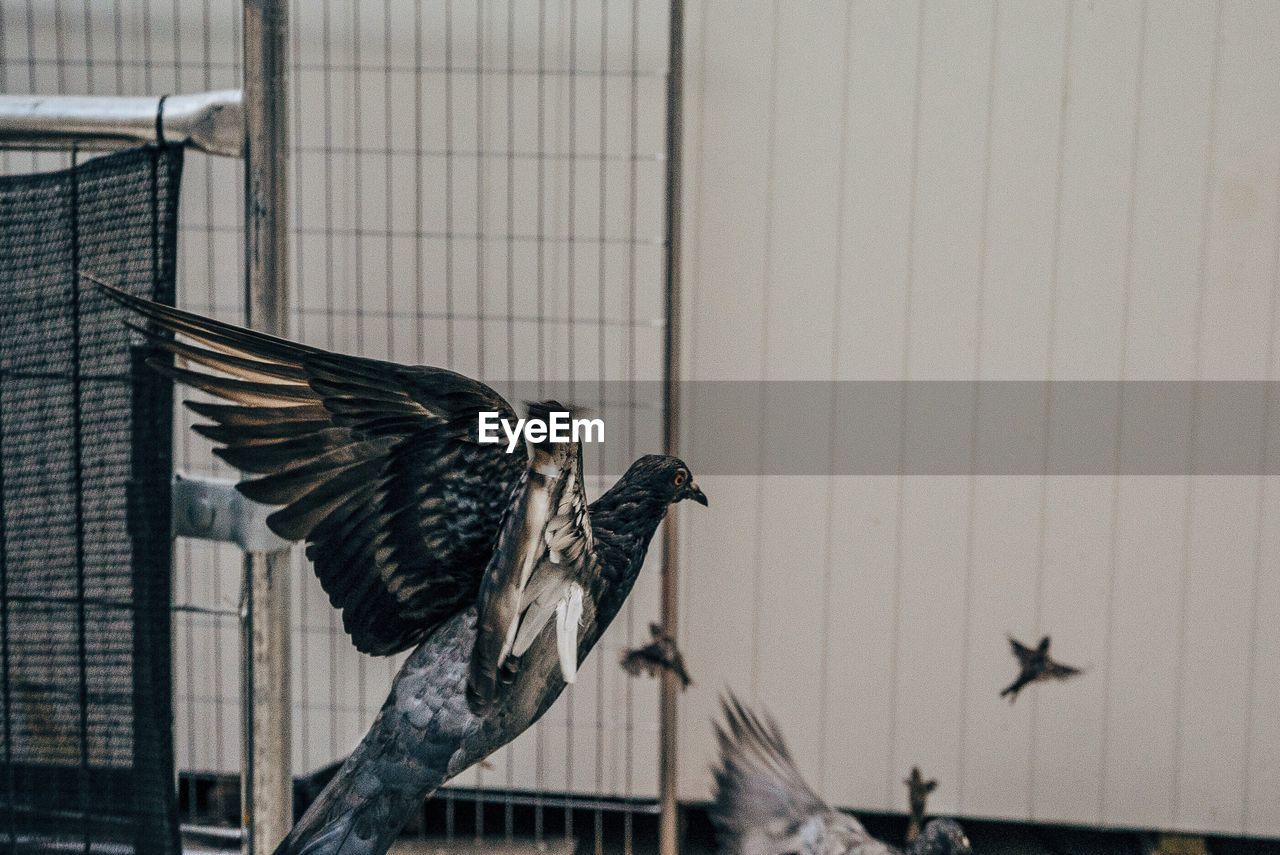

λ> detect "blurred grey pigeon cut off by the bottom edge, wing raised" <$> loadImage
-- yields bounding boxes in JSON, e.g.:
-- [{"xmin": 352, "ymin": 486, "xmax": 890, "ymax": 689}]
[{"xmin": 712, "ymin": 694, "xmax": 973, "ymax": 855}]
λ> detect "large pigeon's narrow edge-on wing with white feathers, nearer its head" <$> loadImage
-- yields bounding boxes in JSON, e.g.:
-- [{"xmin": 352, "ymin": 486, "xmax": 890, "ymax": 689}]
[{"xmin": 470, "ymin": 402, "xmax": 595, "ymax": 709}]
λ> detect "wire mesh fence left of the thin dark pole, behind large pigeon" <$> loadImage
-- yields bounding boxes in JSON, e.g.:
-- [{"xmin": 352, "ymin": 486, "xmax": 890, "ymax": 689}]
[{"xmin": 0, "ymin": 0, "xmax": 669, "ymax": 850}]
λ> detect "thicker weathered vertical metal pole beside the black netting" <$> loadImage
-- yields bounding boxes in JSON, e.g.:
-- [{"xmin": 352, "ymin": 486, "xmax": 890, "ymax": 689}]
[{"xmin": 242, "ymin": 0, "xmax": 293, "ymax": 855}]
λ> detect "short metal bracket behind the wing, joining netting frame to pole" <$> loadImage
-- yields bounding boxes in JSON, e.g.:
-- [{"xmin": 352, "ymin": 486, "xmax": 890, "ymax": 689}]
[{"xmin": 173, "ymin": 472, "xmax": 289, "ymax": 552}]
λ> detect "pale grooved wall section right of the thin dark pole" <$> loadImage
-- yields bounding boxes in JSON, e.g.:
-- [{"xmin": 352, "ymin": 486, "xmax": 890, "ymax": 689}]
[{"xmin": 681, "ymin": 0, "xmax": 1280, "ymax": 836}]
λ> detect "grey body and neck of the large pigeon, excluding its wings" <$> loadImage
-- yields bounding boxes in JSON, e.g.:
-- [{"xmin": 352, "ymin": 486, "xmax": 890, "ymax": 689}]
[{"xmin": 276, "ymin": 468, "xmax": 667, "ymax": 855}]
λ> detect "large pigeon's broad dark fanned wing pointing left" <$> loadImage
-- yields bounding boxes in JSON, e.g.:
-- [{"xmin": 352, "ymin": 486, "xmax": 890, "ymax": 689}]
[{"xmin": 100, "ymin": 283, "xmax": 525, "ymax": 654}]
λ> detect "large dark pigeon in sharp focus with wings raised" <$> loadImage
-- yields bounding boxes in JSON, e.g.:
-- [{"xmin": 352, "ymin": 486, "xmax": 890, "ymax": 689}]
[{"xmin": 86, "ymin": 276, "xmax": 707, "ymax": 855}]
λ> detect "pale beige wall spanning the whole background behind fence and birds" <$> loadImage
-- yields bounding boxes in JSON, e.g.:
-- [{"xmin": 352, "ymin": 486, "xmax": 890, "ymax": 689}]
[{"xmin": 0, "ymin": 0, "xmax": 1280, "ymax": 836}]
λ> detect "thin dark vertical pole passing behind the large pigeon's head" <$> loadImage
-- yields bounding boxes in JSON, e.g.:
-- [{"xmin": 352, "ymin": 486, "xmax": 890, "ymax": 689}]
[{"xmin": 658, "ymin": 0, "xmax": 685, "ymax": 855}]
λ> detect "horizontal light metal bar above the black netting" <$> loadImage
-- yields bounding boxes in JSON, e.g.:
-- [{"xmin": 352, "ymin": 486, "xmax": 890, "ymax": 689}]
[{"xmin": 0, "ymin": 90, "xmax": 244, "ymax": 157}]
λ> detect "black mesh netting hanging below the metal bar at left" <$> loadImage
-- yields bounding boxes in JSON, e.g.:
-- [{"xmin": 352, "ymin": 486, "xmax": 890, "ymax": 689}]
[{"xmin": 0, "ymin": 146, "xmax": 182, "ymax": 854}]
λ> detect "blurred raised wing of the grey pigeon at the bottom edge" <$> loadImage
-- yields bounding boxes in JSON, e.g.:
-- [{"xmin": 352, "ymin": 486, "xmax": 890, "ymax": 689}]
[{"xmin": 712, "ymin": 692, "xmax": 856, "ymax": 852}]
